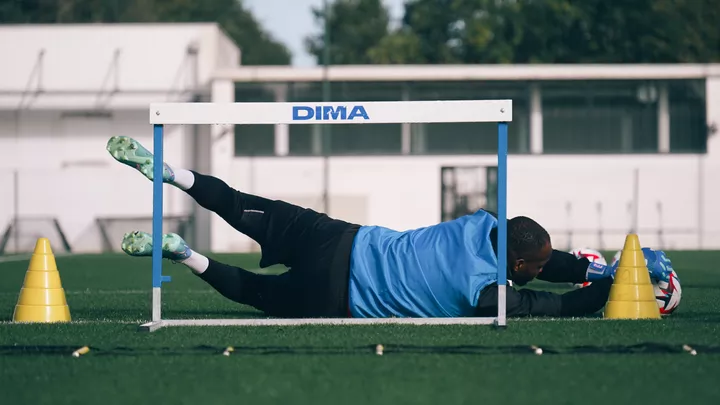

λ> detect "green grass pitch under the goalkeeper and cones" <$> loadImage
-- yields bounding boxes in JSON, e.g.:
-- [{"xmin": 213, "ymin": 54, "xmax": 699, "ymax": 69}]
[{"xmin": 0, "ymin": 252, "xmax": 720, "ymax": 405}]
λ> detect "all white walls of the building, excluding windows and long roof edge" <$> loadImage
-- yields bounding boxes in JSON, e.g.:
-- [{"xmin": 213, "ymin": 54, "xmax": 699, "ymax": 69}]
[{"xmin": 0, "ymin": 24, "xmax": 720, "ymax": 251}]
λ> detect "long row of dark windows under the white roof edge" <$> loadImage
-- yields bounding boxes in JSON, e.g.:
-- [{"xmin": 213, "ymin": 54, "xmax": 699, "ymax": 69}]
[{"xmin": 235, "ymin": 80, "xmax": 708, "ymax": 156}]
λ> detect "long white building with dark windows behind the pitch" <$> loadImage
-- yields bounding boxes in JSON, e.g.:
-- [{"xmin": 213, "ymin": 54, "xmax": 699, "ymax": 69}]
[{"xmin": 0, "ymin": 25, "xmax": 720, "ymax": 252}]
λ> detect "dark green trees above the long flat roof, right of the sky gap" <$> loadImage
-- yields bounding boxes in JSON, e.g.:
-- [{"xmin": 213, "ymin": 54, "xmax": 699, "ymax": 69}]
[{"xmin": 310, "ymin": 0, "xmax": 720, "ymax": 64}]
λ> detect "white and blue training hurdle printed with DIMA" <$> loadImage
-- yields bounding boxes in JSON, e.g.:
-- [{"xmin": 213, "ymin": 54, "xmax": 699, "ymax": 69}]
[{"xmin": 140, "ymin": 100, "xmax": 512, "ymax": 331}]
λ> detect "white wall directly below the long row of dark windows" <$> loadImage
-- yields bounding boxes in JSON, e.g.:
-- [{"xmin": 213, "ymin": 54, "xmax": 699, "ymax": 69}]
[{"xmin": 212, "ymin": 78, "xmax": 720, "ymax": 251}]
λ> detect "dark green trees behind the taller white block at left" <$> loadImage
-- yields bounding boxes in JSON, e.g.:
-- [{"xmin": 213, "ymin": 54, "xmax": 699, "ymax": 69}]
[{"xmin": 0, "ymin": 0, "xmax": 290, "ymax": 65}]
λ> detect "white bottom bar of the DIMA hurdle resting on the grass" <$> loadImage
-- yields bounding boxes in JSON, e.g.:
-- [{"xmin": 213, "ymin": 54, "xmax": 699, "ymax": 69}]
[{"xmin": 140, "ymin": 318, "xmax": 504, "ymax": 332}]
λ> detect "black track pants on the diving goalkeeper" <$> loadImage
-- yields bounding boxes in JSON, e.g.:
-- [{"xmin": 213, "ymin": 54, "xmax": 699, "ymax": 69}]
[{"xmin": 187, "ymin": 172, "xmax": 359, "ymax": 318}]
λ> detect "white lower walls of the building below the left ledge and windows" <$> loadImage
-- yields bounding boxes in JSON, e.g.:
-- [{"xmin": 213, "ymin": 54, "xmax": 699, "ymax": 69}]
[{"xmin": 0, "ymin": 74, "xmax": 720, "ymax": 251}]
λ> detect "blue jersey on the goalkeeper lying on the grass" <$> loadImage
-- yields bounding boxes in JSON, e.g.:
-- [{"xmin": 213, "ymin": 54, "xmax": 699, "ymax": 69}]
[{"xmin": 349, "ymin": 210, "xmax": 497, "ymax": 318}]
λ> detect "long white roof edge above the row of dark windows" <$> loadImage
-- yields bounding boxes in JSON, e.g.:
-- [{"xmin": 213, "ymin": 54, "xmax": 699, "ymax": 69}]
[{"xmin": 214, "ymin": 63, "xmax": 720, "ymax": 82}]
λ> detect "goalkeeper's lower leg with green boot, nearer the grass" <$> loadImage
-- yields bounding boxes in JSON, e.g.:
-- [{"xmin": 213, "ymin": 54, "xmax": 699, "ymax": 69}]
[{"xmin": 121, "ymin": 231, "xmax": 303, "ymax": 317}]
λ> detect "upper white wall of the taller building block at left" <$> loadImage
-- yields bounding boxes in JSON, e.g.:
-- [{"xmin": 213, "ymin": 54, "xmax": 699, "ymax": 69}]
[{"xmin": 0, "ymin": 24, "xmax": 240, "ymax": 110}]
